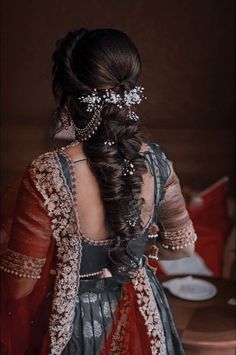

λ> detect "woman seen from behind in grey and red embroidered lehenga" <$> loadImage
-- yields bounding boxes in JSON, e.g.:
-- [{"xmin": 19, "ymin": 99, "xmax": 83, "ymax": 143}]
[{"xmin": 1, "ymin": 29, "xmax": 196, "ymax": 355}]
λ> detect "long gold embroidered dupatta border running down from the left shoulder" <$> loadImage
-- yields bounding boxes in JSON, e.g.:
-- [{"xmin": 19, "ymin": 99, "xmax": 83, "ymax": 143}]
[{"xmin": 32, "ymin": 152, "xmax": 81, "ymax": 355}]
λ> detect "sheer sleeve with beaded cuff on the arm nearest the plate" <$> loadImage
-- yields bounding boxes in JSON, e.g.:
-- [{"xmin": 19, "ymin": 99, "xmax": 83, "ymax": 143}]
[{"xmin": 159, "ymin": 162, "xmax": 197, "ymax": 250}]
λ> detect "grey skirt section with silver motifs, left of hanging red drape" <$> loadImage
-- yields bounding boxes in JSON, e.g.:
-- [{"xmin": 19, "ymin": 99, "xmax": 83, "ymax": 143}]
[{"xmin": 62, "ymin": 278, "xmax": 121, "ymax": 355}]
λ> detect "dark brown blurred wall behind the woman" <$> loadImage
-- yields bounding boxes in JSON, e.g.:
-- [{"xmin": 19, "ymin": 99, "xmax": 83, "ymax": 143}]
[{"xmin": 1, "ymin": 0, "xmax": 235, "ymax": 193}]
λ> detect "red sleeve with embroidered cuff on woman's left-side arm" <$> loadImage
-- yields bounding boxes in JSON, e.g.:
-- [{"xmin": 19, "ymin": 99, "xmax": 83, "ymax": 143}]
[{"xmin": 0, "ymin": 168, "xmax": 51, "ymax": 279}]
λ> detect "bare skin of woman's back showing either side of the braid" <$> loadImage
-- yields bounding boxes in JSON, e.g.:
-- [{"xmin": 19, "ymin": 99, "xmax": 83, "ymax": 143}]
[{"xmin": 64, "ymin": 144, "xmax": 154, "ymax": 240}]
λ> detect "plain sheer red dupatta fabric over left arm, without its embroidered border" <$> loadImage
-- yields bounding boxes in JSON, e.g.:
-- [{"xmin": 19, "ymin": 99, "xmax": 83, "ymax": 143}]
[{"xmin": 0, "ymin": 171, "xmax": 55, "ymax": 355}]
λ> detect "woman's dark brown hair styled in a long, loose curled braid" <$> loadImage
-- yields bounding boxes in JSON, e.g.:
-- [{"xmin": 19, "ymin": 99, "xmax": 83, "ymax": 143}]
[{"xmin": 53, "ymin": 29, "xmax": 146, "ymax": 238}]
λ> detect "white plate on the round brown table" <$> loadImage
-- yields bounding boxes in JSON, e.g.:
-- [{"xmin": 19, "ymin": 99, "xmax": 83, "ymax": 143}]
[{"xmin": 162, "ymin": 276, "xmax": 217, "ymax": 301}]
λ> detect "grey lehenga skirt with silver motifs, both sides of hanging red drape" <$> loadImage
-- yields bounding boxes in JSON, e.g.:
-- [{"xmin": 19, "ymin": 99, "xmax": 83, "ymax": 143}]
[{"xmin": 62, "ymin": 268, "xmax": 184, "ymax": 355}]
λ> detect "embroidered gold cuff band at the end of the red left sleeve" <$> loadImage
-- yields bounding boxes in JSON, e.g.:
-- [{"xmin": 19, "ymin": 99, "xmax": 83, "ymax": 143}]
[{"xmin": 0, "ymin": 249, "xmax": 46, "ymax": 279}]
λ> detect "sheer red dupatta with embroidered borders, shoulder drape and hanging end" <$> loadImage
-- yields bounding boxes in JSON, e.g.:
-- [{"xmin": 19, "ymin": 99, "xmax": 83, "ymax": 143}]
[{"xmin": 1, "ymin": 152, "xmax": 165, "ymax": 355}]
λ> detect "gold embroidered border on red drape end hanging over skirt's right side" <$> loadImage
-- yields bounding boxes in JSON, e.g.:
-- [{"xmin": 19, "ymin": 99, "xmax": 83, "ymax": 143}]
[{"xmin": 132, "ymin": 267, "xmax": 166, "ymax": 355}]
